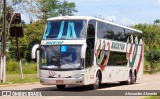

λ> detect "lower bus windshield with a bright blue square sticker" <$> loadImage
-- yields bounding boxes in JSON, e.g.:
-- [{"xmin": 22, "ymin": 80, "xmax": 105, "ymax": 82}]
[{"xmin": 40, "ymin": 45, "xmax": 83, "ymax": 69}]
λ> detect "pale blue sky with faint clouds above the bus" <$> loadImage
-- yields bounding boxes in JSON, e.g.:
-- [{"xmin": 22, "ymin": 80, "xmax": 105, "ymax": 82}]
[{"xmin": 61, "ymin": 0, "xmax": 160, "ymax": 25}]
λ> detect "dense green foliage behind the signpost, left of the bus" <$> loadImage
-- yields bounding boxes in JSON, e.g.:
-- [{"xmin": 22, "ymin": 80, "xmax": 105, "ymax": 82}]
[{"xmin": 8, "ymin": 20, "xmax": 45, "ymax": 61}]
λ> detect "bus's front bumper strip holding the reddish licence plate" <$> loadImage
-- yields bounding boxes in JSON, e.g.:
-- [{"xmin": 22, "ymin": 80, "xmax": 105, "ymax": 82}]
[{"xmin": 40, "ymin": 78, "xmax": 84, "ymax": 85}]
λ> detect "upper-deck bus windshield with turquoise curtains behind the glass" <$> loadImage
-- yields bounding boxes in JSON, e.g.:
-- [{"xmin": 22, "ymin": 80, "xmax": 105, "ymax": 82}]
[{"xmin": 43, "ymin": 20, "xmax": 86, "ymax": 39}]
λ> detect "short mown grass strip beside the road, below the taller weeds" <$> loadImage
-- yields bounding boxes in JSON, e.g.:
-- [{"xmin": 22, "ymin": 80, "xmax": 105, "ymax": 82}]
[{"xmin": 0, "ymin": 74, "xmax": 39, "ymax": 85}]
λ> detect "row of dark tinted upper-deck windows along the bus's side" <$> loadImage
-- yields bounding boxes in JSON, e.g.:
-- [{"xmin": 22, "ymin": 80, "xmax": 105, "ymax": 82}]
[{"xmin": 97, "ymin": 22, "xmax": 141, "ymax": 43}]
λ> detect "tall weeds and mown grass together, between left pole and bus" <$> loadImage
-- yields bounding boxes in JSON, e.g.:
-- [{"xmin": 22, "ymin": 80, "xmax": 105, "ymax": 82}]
[{"xmin": 0, "ymin": 60, "xmax": 39, "ymax": 85}]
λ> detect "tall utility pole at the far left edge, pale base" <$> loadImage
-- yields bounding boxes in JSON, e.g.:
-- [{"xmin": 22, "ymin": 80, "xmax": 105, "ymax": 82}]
[{"xmin": 0, "ymin": 0, "xmax": 6, "ymax": 83}]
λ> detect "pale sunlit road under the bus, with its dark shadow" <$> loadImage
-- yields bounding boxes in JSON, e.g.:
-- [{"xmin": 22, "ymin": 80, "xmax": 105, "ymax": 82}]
[{"xmin": 0, "ymin": 74, "xmax": 160, "ymax": 99}]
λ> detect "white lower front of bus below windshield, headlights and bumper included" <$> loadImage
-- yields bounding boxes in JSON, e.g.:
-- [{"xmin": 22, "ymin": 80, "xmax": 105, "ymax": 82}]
[{"xmin": 40, "ymin": 70, "xmax": 85, "ymax": 85}]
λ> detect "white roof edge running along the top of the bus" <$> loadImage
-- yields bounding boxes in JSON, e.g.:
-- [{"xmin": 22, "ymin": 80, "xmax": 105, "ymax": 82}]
[{"xmin": 47, "ymin": 16, "xmax": 142, "ymax": 33}]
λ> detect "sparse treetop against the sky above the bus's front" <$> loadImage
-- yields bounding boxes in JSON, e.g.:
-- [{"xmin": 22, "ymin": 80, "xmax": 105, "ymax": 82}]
[{"xmin": 38, "ymin": 0, "xmax": 77, "ymax": 19}]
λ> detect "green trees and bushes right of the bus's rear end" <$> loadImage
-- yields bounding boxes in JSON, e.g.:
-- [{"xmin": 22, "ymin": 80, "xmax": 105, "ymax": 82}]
[{"xmin": 133, "ymin": 20, "xmax": 160, "ymax": 72}]
